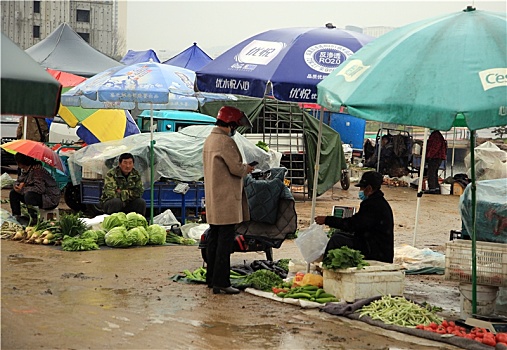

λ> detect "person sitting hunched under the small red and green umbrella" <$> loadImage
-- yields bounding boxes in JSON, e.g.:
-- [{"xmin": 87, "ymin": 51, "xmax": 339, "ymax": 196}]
[{"xmin": 9, "ymin": 152, "xmax": 61, "ymax": 224}]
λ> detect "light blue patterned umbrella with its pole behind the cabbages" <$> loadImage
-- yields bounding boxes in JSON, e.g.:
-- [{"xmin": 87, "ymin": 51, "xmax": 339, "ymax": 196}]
[{"xmin": 62, "ymin": 62, "xmax": 234, "ymax": 222}]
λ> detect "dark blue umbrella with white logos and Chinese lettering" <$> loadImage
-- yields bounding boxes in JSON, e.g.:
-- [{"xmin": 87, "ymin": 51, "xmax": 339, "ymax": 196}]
[{"xmin": 197, "ymin": 24, "xmax": 374, "ymax": 102}]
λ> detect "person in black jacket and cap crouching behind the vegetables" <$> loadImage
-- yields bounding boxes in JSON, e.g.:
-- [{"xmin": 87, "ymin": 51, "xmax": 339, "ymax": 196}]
[{"xmin": 315, "ymin": 171, "xmax": 394, "ymax": 263}]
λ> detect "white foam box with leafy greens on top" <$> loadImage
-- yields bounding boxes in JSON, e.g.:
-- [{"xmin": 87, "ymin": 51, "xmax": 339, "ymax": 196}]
[{"xmin": 323, "ymin": 260, "xmax": 405, "ymax": 302}]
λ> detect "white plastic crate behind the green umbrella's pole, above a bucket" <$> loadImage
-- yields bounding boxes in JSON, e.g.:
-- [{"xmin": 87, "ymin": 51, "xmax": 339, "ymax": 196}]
[{"xmin": 445, "ymin": 240, "xmax": 507, "ymax": 286}]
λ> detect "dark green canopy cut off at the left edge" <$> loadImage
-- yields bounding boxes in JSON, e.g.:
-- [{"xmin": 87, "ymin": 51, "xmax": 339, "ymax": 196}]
[{"xmin": 0, "ymin": 33, "xmax": 61, "ymax": 117}]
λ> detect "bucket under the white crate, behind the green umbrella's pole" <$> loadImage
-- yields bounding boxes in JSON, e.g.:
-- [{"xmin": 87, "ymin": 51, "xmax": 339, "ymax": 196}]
[{"xmin": 459, "ymin": 283, "xmax": 498, "ymax": 320}]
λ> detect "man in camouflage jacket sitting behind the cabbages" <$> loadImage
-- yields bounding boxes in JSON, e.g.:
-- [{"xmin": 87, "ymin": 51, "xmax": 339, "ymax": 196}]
[{"xmin": 100, "ymin": 153, "xmax": 146, "ymax": 215}]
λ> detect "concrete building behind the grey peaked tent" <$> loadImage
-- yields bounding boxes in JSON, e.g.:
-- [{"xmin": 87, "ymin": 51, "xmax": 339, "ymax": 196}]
[{"xmin": 0, "ymin": 0, "xmax": 127, "ymax": 60}]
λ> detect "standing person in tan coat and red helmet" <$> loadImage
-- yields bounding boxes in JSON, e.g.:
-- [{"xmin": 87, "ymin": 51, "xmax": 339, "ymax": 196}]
[{"xmin": 203, "ymin": 106, "xmax": 254, "ymax": 294}]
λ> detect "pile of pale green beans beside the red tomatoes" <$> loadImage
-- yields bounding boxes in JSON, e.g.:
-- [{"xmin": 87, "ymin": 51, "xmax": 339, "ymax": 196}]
[{"xmin": 357, "ymin": 295, "xmax": 443, "ymax": 328}]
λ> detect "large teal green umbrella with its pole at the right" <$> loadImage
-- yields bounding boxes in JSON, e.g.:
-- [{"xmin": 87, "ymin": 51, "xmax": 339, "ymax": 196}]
[{"xmin": 317, "ymin": 7, "xmax": 507, "ymax": 313}]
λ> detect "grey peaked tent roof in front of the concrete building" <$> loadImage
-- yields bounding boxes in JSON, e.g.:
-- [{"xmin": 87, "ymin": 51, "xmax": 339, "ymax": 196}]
[{"xmin": 25, "ymin": 23, "xmax": 123, "ymax": 77}]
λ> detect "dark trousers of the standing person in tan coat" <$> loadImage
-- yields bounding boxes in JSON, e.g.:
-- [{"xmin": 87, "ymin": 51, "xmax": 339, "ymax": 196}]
[{"xmin": 206, "ymin": 224, "xmax": 236, "ymax": 288}]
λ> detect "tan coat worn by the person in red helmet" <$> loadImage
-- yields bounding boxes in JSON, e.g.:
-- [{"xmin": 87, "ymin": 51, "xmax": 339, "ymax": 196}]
[{"xmin": 203, "ymin": 127, "xmax": 250, "ymax": 225}]
